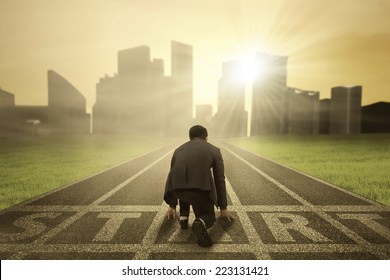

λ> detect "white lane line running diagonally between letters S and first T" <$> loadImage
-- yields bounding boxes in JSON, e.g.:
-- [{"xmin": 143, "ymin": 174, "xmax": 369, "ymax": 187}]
[{"xmin": 11, "ymin": 150, "xmax": 172, "ymax": 259}]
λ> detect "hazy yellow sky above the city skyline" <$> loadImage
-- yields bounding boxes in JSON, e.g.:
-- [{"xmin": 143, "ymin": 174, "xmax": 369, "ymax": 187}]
[{"xmin": 0, "ymin": 0, "xmax": 390, "ymax": 111}]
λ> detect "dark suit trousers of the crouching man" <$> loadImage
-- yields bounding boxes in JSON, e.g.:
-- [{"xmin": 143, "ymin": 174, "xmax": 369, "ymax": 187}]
[{"xmin": 174, "ymin": 190, "xmax": 215, "ymax": 228}]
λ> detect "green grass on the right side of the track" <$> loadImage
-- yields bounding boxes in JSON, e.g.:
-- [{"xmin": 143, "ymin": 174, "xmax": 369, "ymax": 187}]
[{"xmin": 230, "ymin": 134, "xmax": 390, "ymax": 205}]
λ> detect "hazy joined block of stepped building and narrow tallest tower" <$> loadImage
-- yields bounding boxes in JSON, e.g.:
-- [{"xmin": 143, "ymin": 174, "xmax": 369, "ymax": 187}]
[{"xmin": 93, "ymin": 42, "xmax": 193, "ymax": 135}]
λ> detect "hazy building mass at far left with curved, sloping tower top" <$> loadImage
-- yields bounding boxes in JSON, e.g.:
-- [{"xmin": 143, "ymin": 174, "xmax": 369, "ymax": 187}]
[{"xmin": 0, "ymin": 70, "xmax": 90, "ymax": 136}]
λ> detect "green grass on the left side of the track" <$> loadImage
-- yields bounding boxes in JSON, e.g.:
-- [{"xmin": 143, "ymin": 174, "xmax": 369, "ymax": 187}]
[{"xmin": 0, "ymin": 135, "xmax": 174, "ymax": 209}]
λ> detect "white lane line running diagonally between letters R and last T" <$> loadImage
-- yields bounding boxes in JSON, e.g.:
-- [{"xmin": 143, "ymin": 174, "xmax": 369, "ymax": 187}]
[{"xmin": 220, "ymin": 144, "xmax": 388, "ymax": 259}]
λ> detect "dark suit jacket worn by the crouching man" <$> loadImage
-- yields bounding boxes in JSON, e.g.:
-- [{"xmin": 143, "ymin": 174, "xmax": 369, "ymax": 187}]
[{"xmin": 164, "ymin": 139, "xmax": 227, "ymax": 209}]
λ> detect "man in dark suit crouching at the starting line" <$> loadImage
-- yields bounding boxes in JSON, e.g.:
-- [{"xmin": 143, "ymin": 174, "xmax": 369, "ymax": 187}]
[{"xmin": 164, "ymin": 125, "xmax": 235, "ymax": 247}]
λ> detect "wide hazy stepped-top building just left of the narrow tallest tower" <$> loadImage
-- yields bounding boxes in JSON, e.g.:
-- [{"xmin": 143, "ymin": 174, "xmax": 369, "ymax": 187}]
[{"xmin": 93, "ymin": 46, "xmax": 165, "ymax": 135}]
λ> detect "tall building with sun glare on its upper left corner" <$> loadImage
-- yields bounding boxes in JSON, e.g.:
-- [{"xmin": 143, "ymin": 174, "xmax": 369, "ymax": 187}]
[{"xmin": 251, "ymin": 53, "xmax": 288, "ymax": 135}]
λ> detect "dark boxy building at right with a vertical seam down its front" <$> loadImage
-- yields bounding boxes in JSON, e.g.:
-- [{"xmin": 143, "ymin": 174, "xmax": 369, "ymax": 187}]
[{"xmin": 330, "ymin": 86, "xmax": 362, "ymax": 134}]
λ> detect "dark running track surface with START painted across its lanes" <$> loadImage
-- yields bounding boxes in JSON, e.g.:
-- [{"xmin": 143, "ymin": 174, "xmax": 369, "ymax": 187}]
[{"xmin": 0, "ymin": 142, "xmax": 390, "ymax": 260}]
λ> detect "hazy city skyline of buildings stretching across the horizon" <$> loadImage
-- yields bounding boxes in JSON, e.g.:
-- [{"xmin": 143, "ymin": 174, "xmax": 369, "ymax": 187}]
[{"xmin": 0, "ymin": 41, "xmax": 390, "ymax": 137}]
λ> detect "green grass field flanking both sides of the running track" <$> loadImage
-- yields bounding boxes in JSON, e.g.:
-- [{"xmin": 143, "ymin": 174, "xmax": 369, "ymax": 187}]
[{"xmin": 0, "ymin": 134, "xmax": 390, "ymax": 209}]
